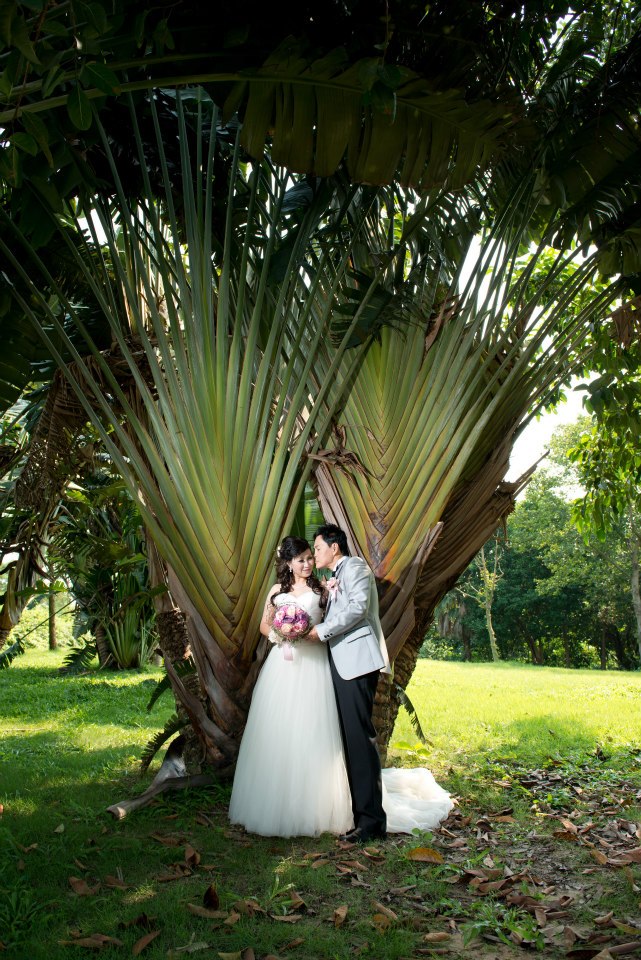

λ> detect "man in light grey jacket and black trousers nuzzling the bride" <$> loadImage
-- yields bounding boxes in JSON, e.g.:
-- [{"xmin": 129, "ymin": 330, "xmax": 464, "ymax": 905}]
[{"xmin": 309, "ymin": 523, "xmax": 391, "ymax": 843}]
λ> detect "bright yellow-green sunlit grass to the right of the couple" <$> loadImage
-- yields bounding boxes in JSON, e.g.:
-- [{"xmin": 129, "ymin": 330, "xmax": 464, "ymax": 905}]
[{"xmin": 391, "ymin": 660, "xmax": 641, "ymax": 768}]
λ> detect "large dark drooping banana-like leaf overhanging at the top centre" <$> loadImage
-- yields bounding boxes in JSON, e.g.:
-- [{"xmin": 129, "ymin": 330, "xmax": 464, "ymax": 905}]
[{"xmin": 225, "ymin": 39, "xmax": 515, "ymax": 190}]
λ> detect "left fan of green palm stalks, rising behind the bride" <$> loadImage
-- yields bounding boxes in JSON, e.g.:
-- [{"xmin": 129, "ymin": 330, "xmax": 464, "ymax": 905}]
[{"xmin": 4, "ymin": 90, "xmax": 432, "ymax": 759}]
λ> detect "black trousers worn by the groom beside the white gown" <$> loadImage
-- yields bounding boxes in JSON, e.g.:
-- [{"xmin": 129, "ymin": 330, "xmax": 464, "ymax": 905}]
[{"xmin": 327, "ymin": 648, "xmax": 387, "ymax": 832}]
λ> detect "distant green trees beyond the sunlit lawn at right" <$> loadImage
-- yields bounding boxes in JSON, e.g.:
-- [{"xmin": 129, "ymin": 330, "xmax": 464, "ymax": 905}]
[{"xmin": 426, "ymin": 417, "xmax": 637, "ymax": 669}]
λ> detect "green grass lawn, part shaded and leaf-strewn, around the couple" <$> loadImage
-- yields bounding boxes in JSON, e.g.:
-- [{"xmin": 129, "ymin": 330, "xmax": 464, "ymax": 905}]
[{"xmin": 0, "ymin": 649, "xmax": 641, "ymax": 960}]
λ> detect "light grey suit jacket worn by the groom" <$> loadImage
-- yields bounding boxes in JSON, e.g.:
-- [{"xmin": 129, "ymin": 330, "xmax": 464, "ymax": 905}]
[{"xmin": 316, "ymin": 557, "xmax": 391, "ymax": 680}]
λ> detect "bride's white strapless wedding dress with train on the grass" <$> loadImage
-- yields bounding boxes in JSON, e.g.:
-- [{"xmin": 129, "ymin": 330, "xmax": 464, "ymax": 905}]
[{"xmin": 229, "ymin": 590, "xmax": 453, "ymax": 837}]
